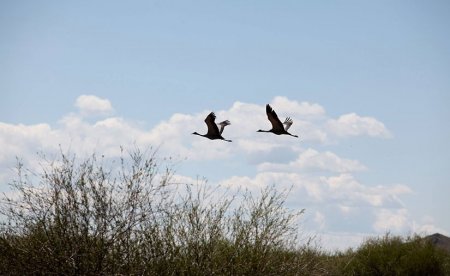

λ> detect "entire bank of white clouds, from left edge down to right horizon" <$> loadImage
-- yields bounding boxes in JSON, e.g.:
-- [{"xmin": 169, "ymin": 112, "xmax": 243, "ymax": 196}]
[{"xmin": 0, "ymin": 95, "xmax": 438, "ymax": 250}]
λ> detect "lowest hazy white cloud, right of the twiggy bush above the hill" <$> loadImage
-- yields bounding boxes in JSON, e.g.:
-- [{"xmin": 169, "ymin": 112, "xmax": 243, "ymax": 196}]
[{"xmin": 221, "ymin": 168, "xmax": 414, "ymax": 239}]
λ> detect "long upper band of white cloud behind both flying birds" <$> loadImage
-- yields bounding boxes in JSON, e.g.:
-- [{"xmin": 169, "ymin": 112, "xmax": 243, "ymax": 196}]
[{"xmin": 0, "ymin": 95, "xmax": 394, "ymax": 172}]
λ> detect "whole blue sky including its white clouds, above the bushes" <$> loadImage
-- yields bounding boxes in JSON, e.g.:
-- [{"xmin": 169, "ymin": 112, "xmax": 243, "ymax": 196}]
[{"xmin": 0, "ymin": 1, "xmax": 450, "ymax": 250}]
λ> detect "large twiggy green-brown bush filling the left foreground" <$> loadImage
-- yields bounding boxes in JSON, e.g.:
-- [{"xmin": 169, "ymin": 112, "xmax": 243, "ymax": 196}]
[{"xmin": 0, "ymin": 150, "xmax": 322, "ymax": 275}]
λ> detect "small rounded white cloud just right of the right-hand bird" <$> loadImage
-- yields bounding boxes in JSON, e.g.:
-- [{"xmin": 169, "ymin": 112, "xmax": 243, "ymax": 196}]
[{"xmin": 326, "ymin": 113, "xmax": 392, "ymax": 138}]
